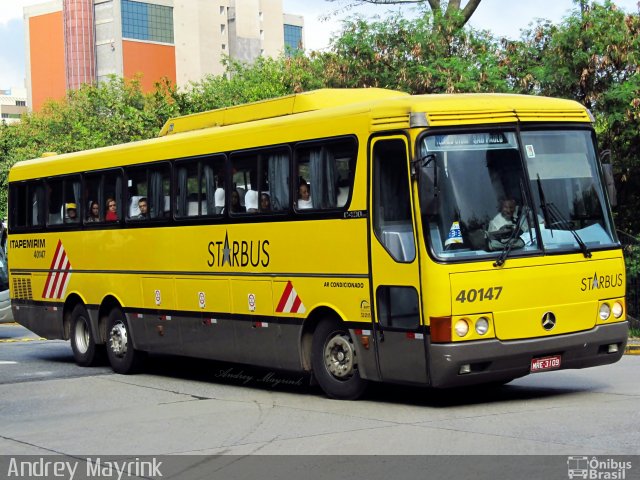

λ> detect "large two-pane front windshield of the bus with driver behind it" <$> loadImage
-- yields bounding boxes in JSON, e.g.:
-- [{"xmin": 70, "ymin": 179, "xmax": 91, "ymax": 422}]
[{"xmin": 418, "ymin": 129, "xmax": 617, "ymax": 259}]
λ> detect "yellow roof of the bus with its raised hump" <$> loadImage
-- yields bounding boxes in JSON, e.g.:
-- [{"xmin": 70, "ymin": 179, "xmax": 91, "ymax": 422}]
[{"xmin": 9, "ymin": 88, "xmax": 593, "ymax": 181}]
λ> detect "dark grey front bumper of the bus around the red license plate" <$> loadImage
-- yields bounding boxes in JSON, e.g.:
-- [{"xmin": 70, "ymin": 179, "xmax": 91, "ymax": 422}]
[{"xmin": 429, "ymin": 321, "xmax": 629, "ymax": 388}]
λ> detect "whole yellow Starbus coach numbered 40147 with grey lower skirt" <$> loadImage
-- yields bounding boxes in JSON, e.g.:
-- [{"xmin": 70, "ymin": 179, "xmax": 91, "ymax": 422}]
[{"xmin": 9, "ymin": 89, "xmax": 628, "ymax": 399}]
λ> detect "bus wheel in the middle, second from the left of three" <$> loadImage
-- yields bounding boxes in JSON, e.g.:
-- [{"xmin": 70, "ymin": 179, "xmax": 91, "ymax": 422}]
[{"xmin": 107, "ymin": 308, "xmax": 144, "ymax": 375}]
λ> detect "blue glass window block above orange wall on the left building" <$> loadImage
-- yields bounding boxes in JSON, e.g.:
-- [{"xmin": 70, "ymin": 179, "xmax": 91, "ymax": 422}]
[{"xmin": 122, "ymin": 0, "xmax": 173, "ymax": 43}]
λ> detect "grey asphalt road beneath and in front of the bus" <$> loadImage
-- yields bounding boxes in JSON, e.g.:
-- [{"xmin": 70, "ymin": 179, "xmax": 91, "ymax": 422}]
[{"xmin": 0, "ymin": 325, "xmax": 640, "ymax": 479}]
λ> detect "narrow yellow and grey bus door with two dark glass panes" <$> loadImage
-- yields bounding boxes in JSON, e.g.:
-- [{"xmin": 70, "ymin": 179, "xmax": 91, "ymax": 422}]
[{"xmin": 369, "ymin": 136, "xmax": 428, "ymax": 384}]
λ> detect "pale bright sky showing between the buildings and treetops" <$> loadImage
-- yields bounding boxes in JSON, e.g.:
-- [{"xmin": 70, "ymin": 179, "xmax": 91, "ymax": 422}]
[{"xmin": 0, "ymin": 0, "xmax": 638, "ymax": 89}]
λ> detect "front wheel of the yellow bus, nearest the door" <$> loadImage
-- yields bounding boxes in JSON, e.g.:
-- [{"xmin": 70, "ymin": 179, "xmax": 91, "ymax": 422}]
[{"xmin": 311, "ymin": 319, "xmax": 367, "ymax": 400}]
